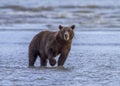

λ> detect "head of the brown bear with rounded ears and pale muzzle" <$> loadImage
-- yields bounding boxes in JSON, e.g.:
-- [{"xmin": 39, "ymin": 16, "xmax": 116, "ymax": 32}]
[{"xmin": 59, "ymin": 25, "xmax": 75, "ymax": 41}]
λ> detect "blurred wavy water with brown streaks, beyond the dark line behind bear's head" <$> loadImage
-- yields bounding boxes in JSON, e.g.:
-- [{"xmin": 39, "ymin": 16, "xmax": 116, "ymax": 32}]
[{"xmin": 0, "ymin": 0, "xmax": 120, "ymax": 30}]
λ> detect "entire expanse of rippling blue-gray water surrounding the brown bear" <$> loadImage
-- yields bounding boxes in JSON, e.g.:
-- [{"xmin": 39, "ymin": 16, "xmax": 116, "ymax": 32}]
[{"xmin": 0, "ymin": 0, "xmax": 120, "ymax": 86}]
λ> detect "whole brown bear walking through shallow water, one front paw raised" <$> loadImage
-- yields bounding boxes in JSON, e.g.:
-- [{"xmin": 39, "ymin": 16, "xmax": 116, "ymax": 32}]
[{"xmin": 29, "ymin": 25, "xmax": 75, "ymax": 67}]
